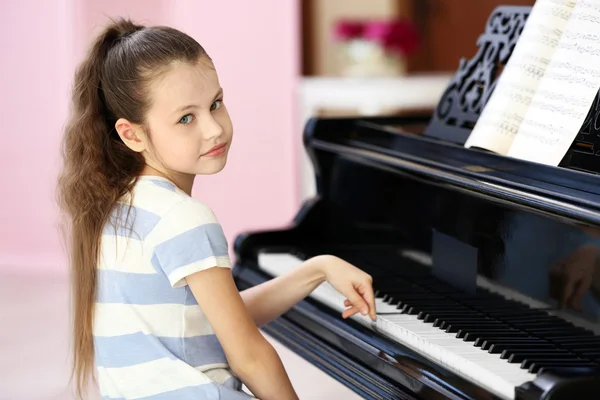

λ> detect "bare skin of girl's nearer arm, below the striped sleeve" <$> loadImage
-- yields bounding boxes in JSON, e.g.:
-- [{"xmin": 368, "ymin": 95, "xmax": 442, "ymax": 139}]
[{"xmin": 186, "ymin": 267, "xmax": 298, "ymax": 400}]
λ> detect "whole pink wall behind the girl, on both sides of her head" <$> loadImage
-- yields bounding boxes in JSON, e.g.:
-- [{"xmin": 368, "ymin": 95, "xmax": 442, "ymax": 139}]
[{"xmin": 0, "ymin": 0, "xmax": 300, "ymax": 272}]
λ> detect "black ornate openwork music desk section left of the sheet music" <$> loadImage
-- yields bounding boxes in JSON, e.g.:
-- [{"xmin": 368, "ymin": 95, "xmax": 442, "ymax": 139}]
[{"xmin": 425, "ymin": 6, "xmax": 531, "ymax": 144}]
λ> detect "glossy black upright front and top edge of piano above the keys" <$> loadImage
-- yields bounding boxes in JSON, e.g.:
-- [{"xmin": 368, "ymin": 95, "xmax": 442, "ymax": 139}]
[{"xmin": 311, "ymin": 116, "xmax": 600, "ymax": 334}]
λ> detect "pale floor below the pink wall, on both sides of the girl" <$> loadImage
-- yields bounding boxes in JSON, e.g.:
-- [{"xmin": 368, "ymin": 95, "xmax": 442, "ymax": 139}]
[{"xmin": 0, "ymin": 274, "xmax": 361, "ymax": 400}]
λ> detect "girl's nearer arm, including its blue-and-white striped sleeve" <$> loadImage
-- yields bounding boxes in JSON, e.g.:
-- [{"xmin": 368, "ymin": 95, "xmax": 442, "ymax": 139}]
[{"xmin": 152, "ymin": 197, "xmax": 298, "ymax": 400}]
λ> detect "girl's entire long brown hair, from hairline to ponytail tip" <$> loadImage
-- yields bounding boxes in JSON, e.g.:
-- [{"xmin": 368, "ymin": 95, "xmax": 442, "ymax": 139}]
[{"xmin": 58, "ymin": 19, "xmax": 208, "ymax": 398}]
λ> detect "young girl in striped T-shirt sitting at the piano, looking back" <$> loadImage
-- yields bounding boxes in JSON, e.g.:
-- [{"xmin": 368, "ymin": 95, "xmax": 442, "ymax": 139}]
[{"xmin": 59, "ymin": 20, "xmax": 375, "ymax": 400}]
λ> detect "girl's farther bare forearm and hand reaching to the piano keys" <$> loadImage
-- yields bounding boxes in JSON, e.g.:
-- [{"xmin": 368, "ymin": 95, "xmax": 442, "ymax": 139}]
[{"xmin": 241, "ymin": 255, "xmax": 375, "ymax": 326}]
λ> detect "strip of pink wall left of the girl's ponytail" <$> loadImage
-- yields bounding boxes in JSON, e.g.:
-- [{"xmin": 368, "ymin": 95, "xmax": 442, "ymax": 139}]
[{"xmin": 0, "ymin": 0, "xmax": 72, "ymax": 269}]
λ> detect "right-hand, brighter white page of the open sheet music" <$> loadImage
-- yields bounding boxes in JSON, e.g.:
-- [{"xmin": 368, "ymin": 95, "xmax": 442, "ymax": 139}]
[{"xmin": 508, "ymin": 0, "xmax": 600, "ymax": 165}]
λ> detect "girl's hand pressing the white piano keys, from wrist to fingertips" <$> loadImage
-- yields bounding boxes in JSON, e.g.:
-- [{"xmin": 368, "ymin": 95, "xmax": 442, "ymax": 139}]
[{"xmin": 319, "ymin": 255, "xmax": 376, "ymax": 321}]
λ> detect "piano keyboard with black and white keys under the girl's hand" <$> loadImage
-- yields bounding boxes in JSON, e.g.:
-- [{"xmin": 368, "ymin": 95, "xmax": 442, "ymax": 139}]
[{"xmin": 258, "ymin": 253, "xmax": 600, "ymax": 399}]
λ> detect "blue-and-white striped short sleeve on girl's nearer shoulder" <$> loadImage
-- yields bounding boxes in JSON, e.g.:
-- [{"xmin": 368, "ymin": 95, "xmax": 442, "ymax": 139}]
[{"xmin": 148, "ymin": 198, "xmax": 231, "ymax": 287}]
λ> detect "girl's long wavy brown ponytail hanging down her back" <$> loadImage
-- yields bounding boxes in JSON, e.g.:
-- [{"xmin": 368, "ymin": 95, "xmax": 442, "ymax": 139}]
[{"xmin": 59, "ymin": 18, "xmax": 144, "ymax": 398}]
